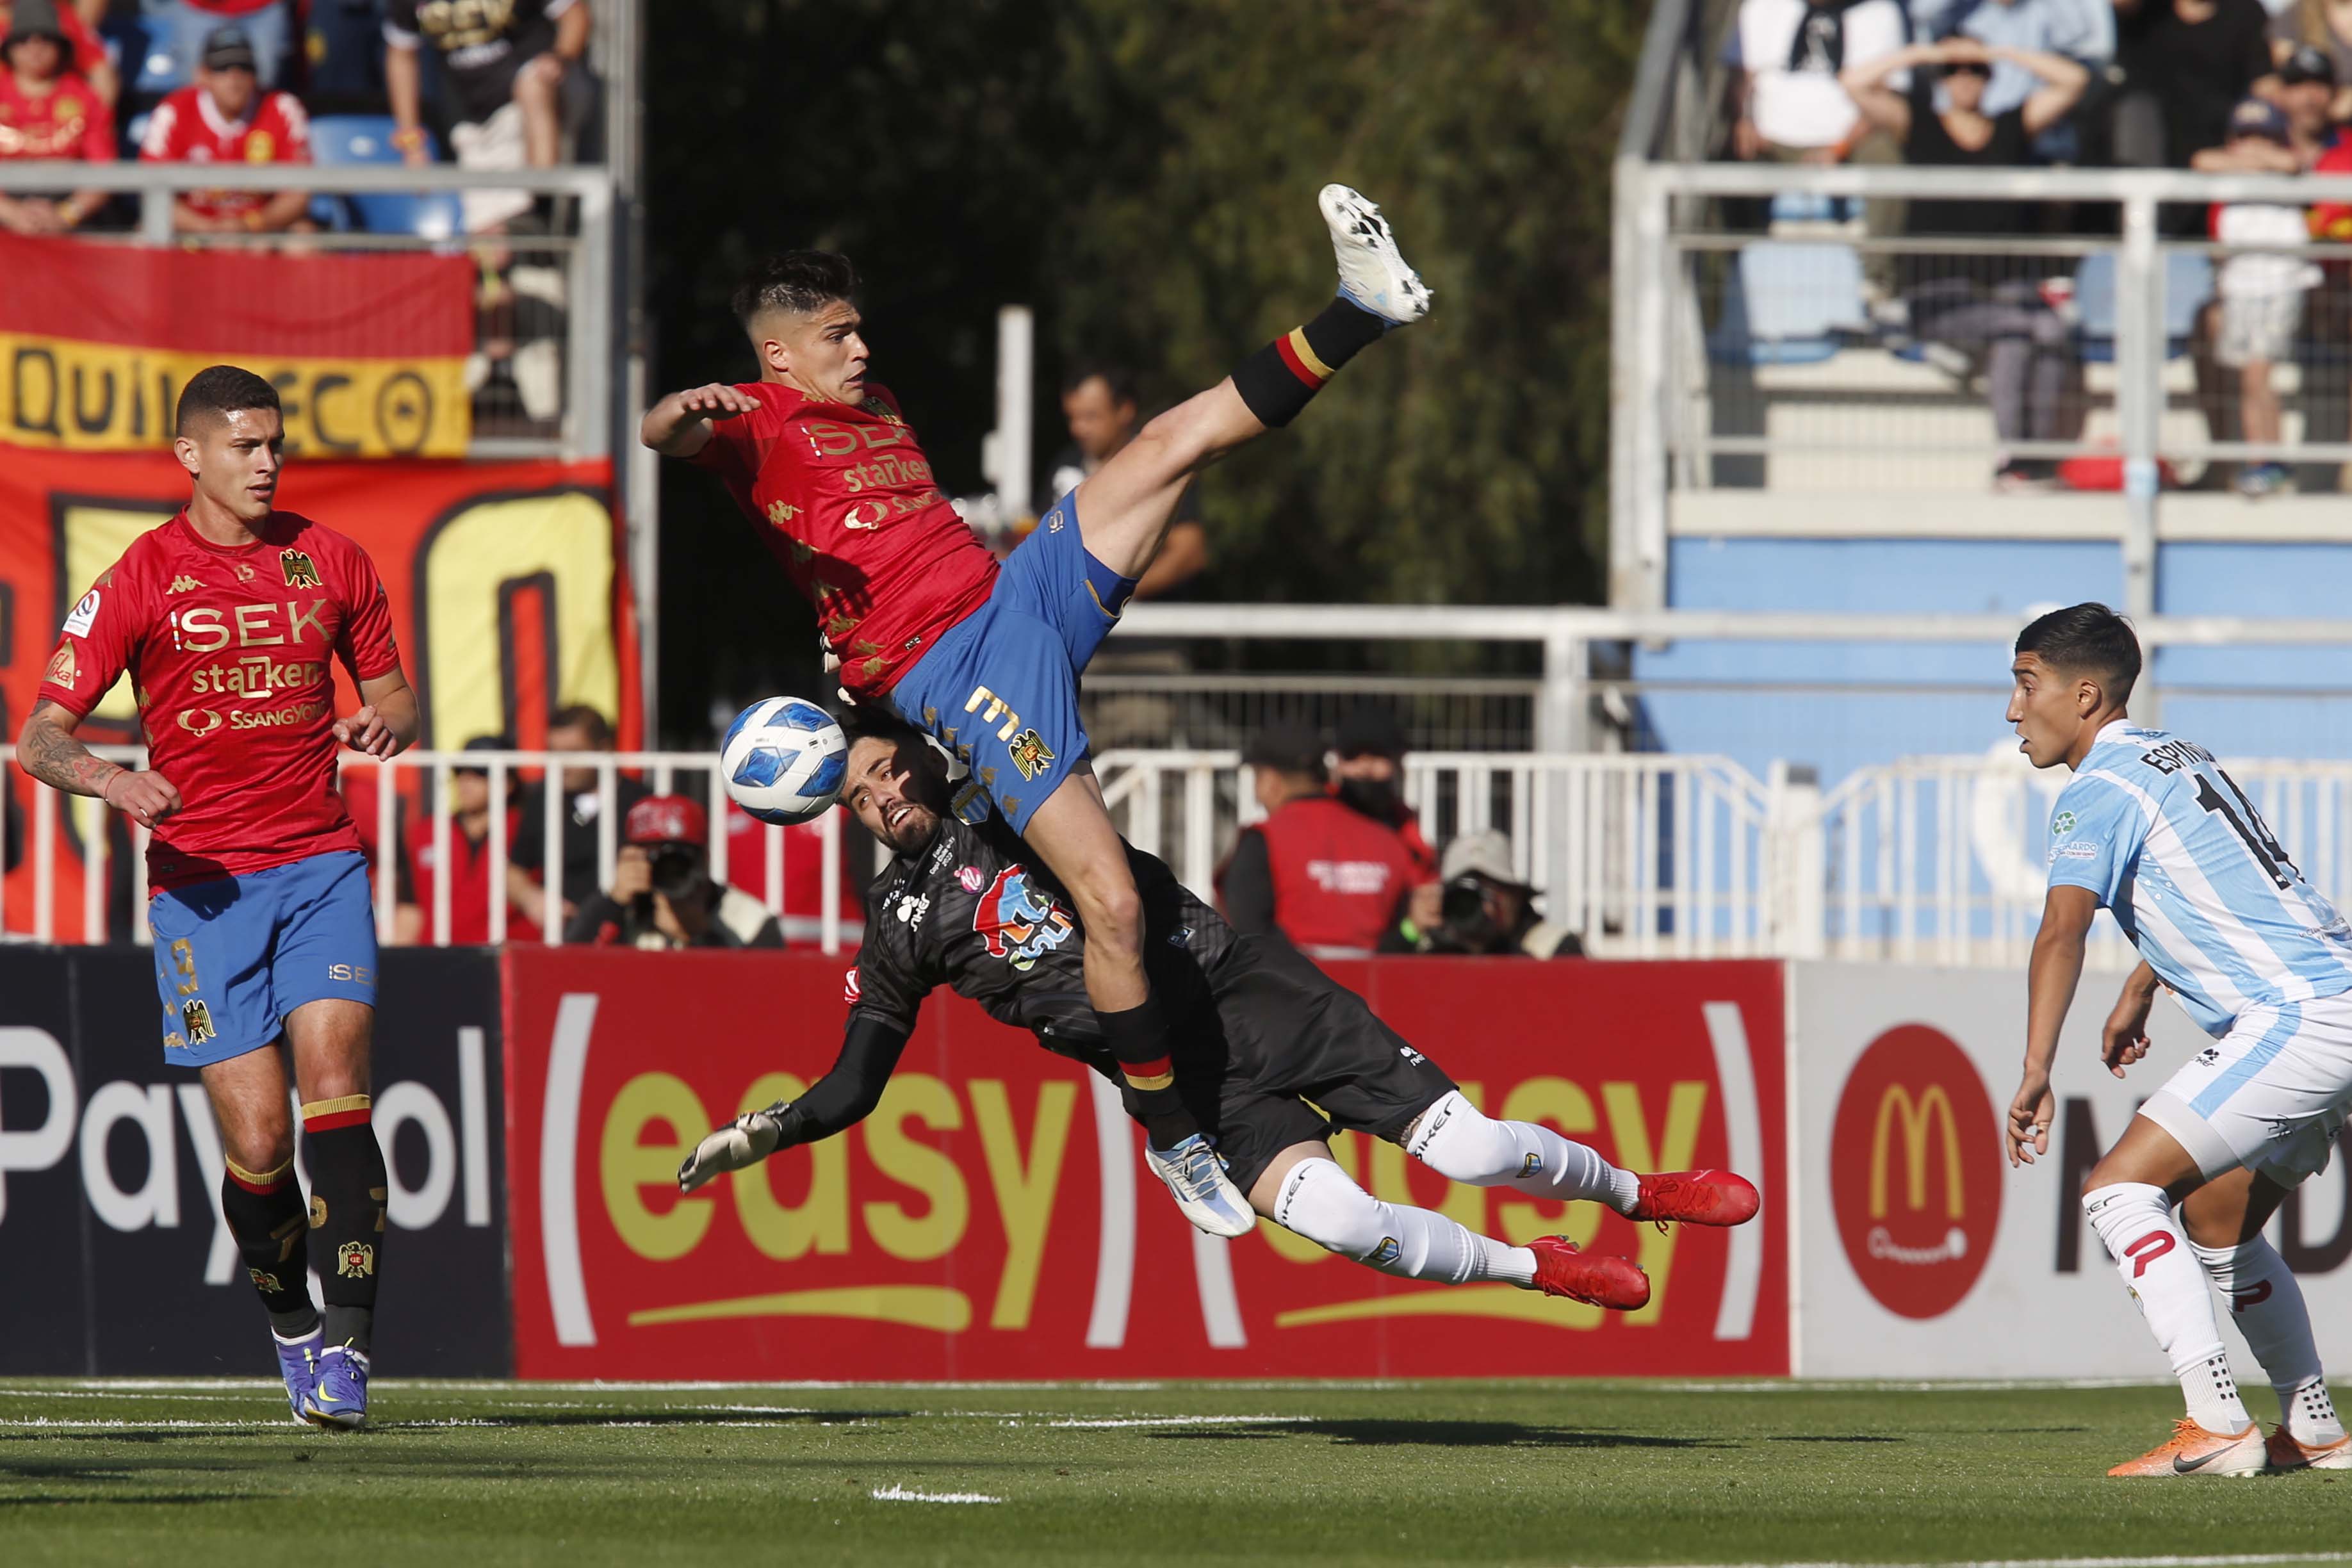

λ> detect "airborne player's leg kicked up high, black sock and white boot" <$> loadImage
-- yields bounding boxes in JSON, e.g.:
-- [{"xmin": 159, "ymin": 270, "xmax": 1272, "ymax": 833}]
[{"xmin": 1075, "ymin": 186, "xmax": 1430, "ymax": 587}]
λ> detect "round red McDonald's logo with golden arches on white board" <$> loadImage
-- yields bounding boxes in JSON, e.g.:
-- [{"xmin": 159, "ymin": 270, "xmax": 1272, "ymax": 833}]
[{"xmin": 1830, "ymin": 1023, "xmax": 2002, "ymax": 1319}]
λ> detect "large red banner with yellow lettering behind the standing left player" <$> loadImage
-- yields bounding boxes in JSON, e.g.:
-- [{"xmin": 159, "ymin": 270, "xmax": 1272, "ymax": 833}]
[{"xmin": 0, "ymin": 446, "xmax": 642, "ymax": 940}]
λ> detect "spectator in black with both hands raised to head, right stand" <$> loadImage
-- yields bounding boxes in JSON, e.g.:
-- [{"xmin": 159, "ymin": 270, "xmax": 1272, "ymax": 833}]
[{"xmin": 1844, "ymin": 38, "xmax": 2091, "ymax": 489}]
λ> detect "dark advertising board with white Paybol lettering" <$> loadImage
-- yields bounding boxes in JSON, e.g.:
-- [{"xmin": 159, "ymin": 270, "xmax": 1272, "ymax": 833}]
[{"xmin": 0, "ymin": 947, "xmax": 510, "ymax": 1378}]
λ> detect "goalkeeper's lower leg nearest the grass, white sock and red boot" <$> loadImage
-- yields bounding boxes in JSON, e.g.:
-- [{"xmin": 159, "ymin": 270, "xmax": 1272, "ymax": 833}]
[{"xmin": 1249, "ymin": 1143, "xmax": 1649, "ymax": 1312}]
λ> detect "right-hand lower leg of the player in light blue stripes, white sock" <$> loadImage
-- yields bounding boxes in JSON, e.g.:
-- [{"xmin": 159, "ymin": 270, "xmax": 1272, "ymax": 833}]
[{"xmin": 2180, "ymin": 1168, "xmax": 2352, "ymax": 1469}]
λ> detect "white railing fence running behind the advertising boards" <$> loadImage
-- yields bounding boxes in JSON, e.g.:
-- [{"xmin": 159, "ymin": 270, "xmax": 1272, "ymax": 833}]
[{"xmin": 18, "ymin": 747, "xmax": 2352, "ymax": 966}]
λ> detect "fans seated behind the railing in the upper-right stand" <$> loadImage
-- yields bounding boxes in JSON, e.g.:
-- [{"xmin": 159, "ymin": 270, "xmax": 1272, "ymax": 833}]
[{"xmin": 1726, "ymin": 0, "xmax": 2352, "ymax": 496}]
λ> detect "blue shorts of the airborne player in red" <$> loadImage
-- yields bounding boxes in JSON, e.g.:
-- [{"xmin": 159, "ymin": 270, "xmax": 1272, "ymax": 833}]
[{"xmin": 892, "ymin": 491, "xmax": 1136, "ymax": 832}]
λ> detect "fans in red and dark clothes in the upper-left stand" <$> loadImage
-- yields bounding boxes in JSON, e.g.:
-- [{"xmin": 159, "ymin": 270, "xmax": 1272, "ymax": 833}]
[{"xmin": 0, "ymin": 0, "xmax": 595, "ymax": 235}]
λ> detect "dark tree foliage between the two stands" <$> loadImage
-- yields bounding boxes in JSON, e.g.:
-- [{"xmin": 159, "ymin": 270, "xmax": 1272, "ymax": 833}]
[{"xmin": 647, "ymin": 0, "xmax": 1642, "ymax": 719}]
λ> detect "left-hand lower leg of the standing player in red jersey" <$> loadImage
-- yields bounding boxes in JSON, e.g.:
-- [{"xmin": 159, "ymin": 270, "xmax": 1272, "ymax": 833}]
[{"xmin": 202, "ymin": 1046, "xmax": 327, "ymax": 1420}]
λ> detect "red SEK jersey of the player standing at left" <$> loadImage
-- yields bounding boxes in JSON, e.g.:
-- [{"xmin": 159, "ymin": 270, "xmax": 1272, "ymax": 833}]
[{"xmin": 40, "ymin": 512, "xmax": 400, "ymax": 891}]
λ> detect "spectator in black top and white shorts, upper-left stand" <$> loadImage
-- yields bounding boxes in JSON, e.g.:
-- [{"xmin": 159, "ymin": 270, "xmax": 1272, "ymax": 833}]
[{"xmin": 384, "ymin": 0, "xmax": 591, "ymax": 233}]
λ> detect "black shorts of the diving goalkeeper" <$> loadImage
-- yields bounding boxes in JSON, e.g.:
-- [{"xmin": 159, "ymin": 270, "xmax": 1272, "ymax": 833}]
[{"xmin": 1176, "ymin": 936, "xmax": 1453, "ymax": 1196}]
